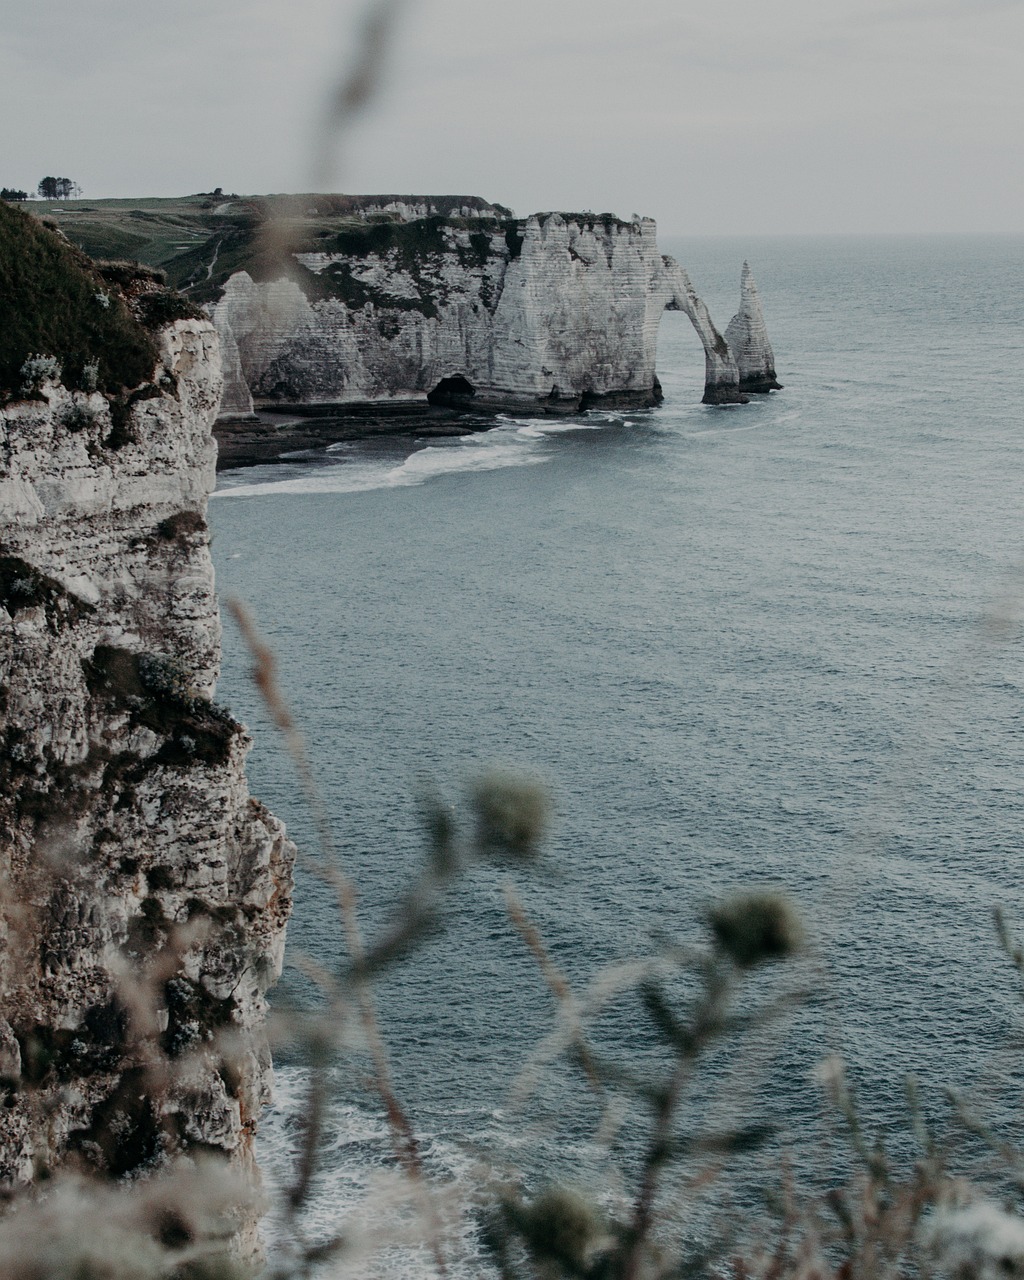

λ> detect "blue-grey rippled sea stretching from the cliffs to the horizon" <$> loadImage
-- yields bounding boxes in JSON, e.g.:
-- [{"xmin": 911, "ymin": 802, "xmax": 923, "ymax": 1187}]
[{"xmin": 210, "ymin": 237, "xmax": 1024, "ymax": 1277}]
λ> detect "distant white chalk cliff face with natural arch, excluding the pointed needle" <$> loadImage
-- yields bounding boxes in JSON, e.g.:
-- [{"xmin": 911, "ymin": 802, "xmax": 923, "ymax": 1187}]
[{"xmin": 211, "ymin": 214, "xmax": 768, "ymax": 415}]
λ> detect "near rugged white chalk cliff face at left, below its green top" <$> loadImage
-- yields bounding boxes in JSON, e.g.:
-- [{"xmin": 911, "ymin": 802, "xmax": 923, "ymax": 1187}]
[{"xmin": 0, "ymin": 320, "xmax": 294, "ymax": 1226}]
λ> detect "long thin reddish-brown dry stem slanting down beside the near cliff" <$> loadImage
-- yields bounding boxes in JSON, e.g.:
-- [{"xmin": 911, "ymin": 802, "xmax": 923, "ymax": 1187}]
[{"xmin": 227, "ymin": 599, "xmax": 447, "ymax": 1276}]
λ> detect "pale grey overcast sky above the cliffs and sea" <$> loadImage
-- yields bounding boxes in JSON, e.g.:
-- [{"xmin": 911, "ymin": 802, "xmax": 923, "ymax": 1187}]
[{"xmin": 0, "ymin": 0, "xmax": 1024, "ymax": 236}]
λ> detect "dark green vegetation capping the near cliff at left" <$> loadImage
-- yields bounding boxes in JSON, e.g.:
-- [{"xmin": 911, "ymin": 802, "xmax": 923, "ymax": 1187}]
[{"xmin": 0, "ymin": 202, "xmax": 156, "ymax": 394}]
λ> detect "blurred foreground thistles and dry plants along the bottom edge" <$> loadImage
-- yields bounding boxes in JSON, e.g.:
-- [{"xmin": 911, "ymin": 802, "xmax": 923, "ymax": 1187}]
[{"xmin": 0, "ymin": 607, "xmax": 1024, "ymax": 1280}]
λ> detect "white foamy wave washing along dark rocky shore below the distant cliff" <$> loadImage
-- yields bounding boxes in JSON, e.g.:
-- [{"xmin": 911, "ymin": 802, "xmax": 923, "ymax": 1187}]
[{"xmin": 212, "ymin": 413, "xmax": 609, "ymax": 498}]
